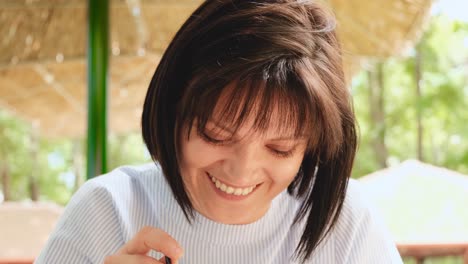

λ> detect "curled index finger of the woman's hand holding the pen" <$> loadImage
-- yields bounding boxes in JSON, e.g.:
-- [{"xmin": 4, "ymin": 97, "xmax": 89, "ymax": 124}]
[{"xmin": 120, "ymin": 227, "xmax": 183, "ymax": 260}]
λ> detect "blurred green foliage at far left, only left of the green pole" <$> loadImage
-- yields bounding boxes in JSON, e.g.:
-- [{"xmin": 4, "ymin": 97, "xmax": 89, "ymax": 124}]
[{"xmin": 0, "ymin": 111, "xmax": 75, "ymax": 204}]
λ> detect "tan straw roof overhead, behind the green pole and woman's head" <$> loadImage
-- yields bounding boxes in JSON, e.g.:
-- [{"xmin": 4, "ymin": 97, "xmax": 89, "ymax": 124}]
[{"xmin": 0, "ymin": 0, "xmax": 431, "ymax": 137}]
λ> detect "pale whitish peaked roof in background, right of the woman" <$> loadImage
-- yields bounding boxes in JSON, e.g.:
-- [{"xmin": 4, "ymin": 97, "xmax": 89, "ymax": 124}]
[{"xmin": 359, "ymin": 160, "xmax": 468, "ymax": 245}]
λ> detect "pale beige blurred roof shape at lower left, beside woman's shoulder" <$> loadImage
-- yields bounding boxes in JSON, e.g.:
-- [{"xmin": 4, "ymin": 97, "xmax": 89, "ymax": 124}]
[{"xmin": 0, "ymin": 202, "xmax": 63, "ymax": 262}]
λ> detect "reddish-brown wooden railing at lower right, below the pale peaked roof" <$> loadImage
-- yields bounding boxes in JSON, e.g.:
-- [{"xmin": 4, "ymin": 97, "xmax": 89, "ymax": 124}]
[{"xmin": 397, "ymin": 242, "xmax": 468, "ymax": 264}]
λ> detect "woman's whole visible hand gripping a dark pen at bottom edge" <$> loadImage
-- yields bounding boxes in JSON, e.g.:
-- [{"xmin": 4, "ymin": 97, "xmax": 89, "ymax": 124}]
[{"xmin": 104, "ymin": 227, "xmax": 183, "ymax": 264}]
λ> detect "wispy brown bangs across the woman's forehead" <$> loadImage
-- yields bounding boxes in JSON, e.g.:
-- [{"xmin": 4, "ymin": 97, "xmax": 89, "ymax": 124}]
[{"xmin": 180, "ymin": 69, "xmax": 318, "ymax": 147}]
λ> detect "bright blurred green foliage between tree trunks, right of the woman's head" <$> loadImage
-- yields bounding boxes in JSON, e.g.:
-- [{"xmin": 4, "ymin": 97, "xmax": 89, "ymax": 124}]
[{"xmin": 352, "ymin": 16, "xmax": 468, "ymax": 178}]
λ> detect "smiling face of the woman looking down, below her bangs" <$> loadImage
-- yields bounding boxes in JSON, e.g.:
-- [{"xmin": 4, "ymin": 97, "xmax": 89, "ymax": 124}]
[{"xmin": 176, "ymin": 87, "xmax": 307, "ymax": 224}]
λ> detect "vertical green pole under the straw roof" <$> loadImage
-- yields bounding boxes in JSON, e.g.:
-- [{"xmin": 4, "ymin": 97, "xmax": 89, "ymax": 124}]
[{"xmin": 86, "ymin": 0, "xmax": 109, "ymax": 179}]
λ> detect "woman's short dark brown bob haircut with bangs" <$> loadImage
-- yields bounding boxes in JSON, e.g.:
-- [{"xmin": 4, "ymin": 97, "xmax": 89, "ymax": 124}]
[{"xmin": 142, "ymin": 0, "xmax": 357, "ymax": 260}]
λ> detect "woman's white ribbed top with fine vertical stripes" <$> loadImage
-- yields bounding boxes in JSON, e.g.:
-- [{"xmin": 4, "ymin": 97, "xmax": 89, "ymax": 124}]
[{"xmin": 36, "ymin": 164, "xmax": 402, "ymax": 264}]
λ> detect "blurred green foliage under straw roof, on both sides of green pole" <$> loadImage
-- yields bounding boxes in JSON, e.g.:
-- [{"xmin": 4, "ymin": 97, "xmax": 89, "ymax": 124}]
[{"xmin": 0, "ymin": 110, "xmax": 151, "ymax": 205}]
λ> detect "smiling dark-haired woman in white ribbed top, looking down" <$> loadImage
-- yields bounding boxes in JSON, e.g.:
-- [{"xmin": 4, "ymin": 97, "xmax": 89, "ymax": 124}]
[{"xmin": 37, "ymin": 0, "xmax": 401, "ymax": 264}]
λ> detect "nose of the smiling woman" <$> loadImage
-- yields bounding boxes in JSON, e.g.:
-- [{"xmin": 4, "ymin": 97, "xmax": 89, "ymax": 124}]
[{"xmin": 223, "ymin": 143, "xmax": 262, "ymax": 186}]
